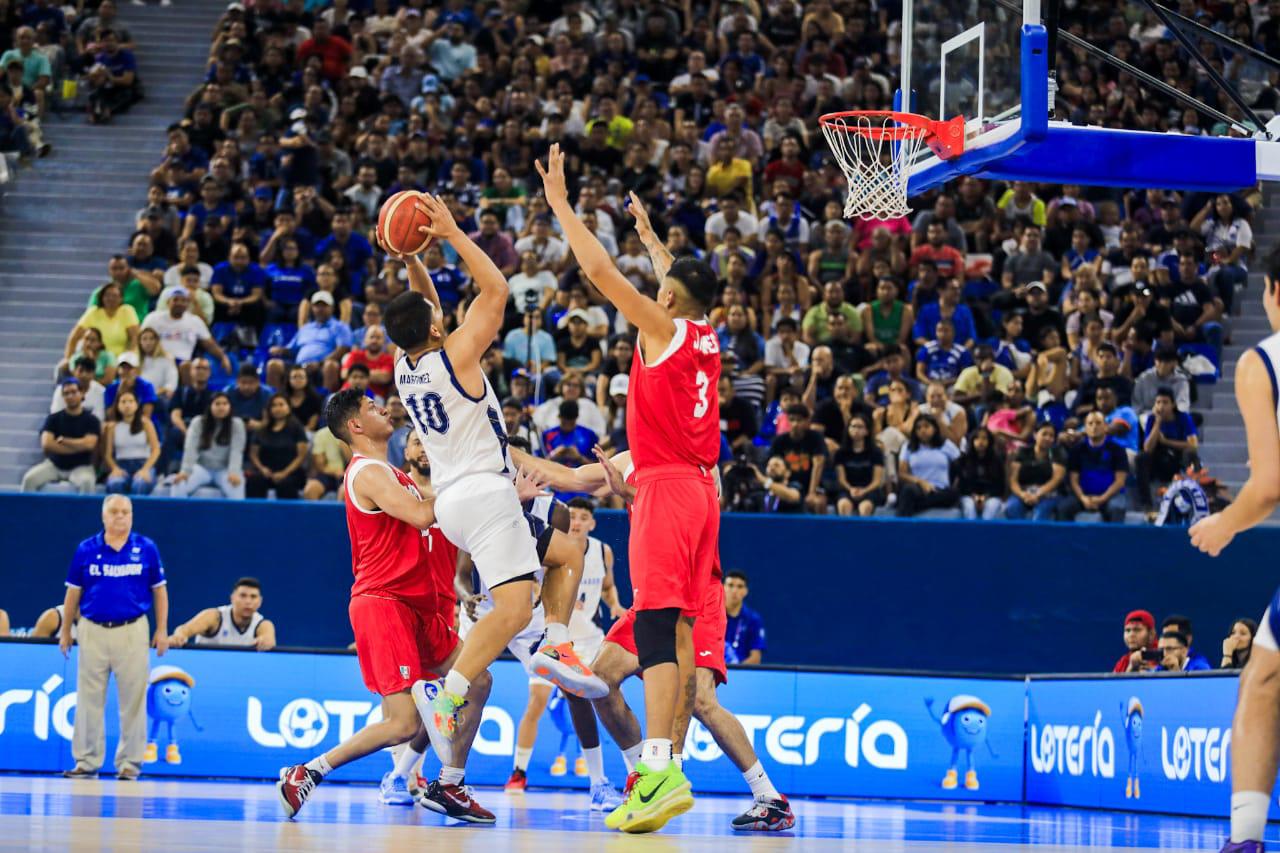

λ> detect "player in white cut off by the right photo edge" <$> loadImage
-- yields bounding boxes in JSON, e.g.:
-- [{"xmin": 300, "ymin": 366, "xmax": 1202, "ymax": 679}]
[{"xmin": 1189, "ymin": 252, "xmax": 1280, "ymax": 853}]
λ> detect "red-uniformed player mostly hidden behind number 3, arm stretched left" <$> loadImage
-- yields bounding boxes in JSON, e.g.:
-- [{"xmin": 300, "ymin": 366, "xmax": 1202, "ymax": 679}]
[{"xmin": 513, "ymin": 448, "xmax": 795, "ymax": 831}]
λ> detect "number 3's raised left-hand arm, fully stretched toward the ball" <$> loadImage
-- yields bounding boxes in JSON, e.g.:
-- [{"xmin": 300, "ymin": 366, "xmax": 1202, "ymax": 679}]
[{"xmin": 534, "ymin": 143, "xmax": 676, "ymax": 352}]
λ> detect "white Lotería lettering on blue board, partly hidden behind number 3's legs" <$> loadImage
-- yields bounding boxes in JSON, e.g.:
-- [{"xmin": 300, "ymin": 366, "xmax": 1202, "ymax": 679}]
[{"xmin": 685, "ymin": 702, "xmax": 908, "ymax": 770}]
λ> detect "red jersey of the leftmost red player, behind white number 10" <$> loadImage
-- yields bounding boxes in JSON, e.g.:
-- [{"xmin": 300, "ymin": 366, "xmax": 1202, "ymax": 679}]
[{"xmin": 343, "ymin": 455, "xmax": 457, "ymax": 610}]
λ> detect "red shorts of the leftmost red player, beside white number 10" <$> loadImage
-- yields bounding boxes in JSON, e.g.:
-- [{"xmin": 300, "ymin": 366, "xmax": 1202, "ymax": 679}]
[{"xmin": 347, "ymin": 596, "xmax": 458, "ymax": 695}]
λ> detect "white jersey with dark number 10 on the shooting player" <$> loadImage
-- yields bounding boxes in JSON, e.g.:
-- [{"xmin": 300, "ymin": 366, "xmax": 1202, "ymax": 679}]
[{"xmin": 396, "ymin": 347, "xmax": 515, "ymax": 494}]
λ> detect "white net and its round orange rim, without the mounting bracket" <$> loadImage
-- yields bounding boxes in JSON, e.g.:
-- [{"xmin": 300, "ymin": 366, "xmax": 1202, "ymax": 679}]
[{"xmin": 822, "ymin": 115, "xmax": 927, "ymax": 219}]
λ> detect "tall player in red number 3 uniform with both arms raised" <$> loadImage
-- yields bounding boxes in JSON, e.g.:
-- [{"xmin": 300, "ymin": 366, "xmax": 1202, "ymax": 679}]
[{"xmin": 536, "ymin": 145, "xmax": 721, "ymax": 833}]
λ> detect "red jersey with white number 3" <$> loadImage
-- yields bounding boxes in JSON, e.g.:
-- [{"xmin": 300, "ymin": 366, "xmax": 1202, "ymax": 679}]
[{"xmin": 627, "ymin": 319, "xmax": 721, "ymax": 471}]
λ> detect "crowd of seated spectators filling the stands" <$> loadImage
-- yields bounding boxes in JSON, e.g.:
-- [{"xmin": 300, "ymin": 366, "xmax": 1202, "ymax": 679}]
[{"xmin": 15, "ymin": 0, "xmax": 1280, "ymax": 521}]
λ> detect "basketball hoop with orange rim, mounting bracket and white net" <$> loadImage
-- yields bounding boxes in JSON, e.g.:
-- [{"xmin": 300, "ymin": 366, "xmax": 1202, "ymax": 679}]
[{"xmin": 818, "ymin": 110, "xmax": 964, "ymax": 219}]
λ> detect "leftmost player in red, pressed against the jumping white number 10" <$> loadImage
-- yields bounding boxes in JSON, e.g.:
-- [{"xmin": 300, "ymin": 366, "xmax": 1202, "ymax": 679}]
[{"xmin": 276, "ymin": 389, "xmax": 494, "ymax": 824}]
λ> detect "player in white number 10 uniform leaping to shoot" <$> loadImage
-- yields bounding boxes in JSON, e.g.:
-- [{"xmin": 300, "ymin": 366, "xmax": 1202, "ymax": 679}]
[{"xmin": 384, "ymin": 195, "xmax": 608, "ymax": 738}]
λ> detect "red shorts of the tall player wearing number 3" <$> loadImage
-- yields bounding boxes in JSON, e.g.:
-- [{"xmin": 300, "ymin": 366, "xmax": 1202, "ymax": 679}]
[{"xmin": 627, "ymin": 465, "xmax": 719, "ymax": 616}]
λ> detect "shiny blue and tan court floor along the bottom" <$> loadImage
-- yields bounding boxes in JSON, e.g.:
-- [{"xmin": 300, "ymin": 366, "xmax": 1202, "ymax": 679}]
[{"xmin": 0, "ymin": 775, "xmax": 1264, "ymax": 853}]
